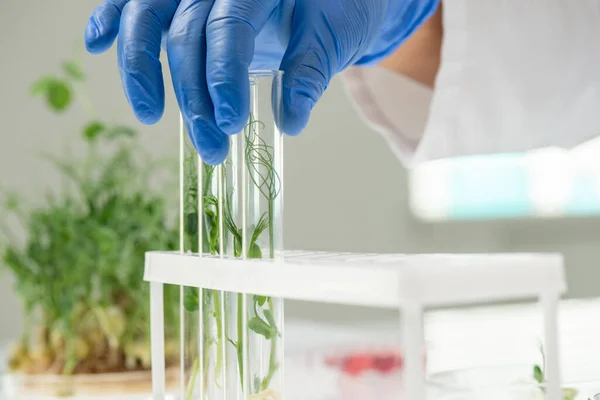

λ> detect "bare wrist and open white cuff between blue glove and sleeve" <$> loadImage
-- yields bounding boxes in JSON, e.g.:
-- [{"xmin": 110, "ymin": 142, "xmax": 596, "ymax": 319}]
[{"xmin": 343, "ymin": 4, "xmax": 443, "ymax": 165}]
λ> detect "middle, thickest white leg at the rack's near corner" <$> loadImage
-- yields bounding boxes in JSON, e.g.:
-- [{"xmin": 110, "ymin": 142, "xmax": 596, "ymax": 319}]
[{"xmin": 400, "ymin": 304, "xmax": 426, "ymax": 400}]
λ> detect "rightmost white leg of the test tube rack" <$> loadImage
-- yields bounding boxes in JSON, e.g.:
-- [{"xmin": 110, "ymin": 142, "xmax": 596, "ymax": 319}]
[{"xmin": 540, "ymin": 294, "xmax": 562, "ymax": 400}]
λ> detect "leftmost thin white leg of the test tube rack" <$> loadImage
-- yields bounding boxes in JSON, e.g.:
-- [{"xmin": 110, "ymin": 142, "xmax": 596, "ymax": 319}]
[{"xmin": 150, "ymin": 282, "xmax": 166, "ymax": 400}]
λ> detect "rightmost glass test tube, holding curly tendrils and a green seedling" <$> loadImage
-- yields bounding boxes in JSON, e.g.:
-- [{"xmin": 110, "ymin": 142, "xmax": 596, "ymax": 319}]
[{"xmin": 237, "ymin": 71, "xmax": 283, "ymax": 400}]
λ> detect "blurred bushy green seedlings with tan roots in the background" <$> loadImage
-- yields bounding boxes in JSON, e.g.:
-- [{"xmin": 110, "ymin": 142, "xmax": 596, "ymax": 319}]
[{"xmin": 0, "ymin": 56, "xmax": 179, "ymax": 398}]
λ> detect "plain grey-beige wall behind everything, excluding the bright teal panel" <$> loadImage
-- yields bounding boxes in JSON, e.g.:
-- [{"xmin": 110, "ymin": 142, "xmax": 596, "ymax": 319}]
[{"xmin": 0, "ymin": 0, "xmax": 600, "ymax": 342}]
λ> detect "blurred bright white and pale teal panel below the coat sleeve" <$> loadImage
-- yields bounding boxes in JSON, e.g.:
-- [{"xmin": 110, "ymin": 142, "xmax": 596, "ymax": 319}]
[{"xmin": 412, "ymin": 153, "xmax": 600, "ymax": 220}]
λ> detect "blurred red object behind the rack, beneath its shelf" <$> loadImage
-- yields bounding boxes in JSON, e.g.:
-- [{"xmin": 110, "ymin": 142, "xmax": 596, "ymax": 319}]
[{"xmin": 325, "ymin": 351, "xmax": 404, "ymax": 376}]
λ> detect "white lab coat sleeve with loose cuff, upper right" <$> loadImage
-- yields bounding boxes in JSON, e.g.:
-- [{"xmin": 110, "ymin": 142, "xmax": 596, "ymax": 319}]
[{"xmin": 344, "ymin": 0, "xmax": 600, "ymax": 166}]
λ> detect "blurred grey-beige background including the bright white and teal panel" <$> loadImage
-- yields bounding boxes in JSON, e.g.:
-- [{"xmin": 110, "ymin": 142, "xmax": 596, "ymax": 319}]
[{"xmin": 0, "ymin": 0, "xmax": 600, "ymax": 342}]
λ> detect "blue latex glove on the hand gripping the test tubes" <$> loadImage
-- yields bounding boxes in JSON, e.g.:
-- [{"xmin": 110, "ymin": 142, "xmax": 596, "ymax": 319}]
[{"xmin": 85, "ymin": 0, "xmax": 439, "ymax": 164}]
